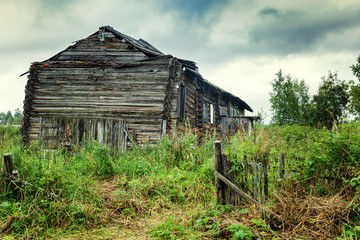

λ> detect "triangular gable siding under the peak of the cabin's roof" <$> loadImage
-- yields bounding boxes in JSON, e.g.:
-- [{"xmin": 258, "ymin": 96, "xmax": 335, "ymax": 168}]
[{"xmin": 57, "ymin": 33, "xmax": 149, "ymax": 63}]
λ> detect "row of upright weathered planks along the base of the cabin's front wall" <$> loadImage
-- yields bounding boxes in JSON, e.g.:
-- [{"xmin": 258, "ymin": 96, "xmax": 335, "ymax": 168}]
[{"xmin": 38, "ymin": 117, "xmax": 130, "ymax": 153}]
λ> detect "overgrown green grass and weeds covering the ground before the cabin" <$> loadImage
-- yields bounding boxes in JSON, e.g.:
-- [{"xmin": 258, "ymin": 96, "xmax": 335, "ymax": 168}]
[{"xmin": 0, "ymin": 123, "xmax": 360, "ymax": 239}]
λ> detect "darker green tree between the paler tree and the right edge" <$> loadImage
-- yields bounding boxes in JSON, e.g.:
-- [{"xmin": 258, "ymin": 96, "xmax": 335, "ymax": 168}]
[{"xmin": 307, "ymin": 72, "xmax": 350, "ymax": 128}]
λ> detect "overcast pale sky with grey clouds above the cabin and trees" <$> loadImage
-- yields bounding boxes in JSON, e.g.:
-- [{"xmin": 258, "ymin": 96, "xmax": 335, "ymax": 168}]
[{"xmin": 0, "ymin": 0, "xmax": 360, "ymax": 122}]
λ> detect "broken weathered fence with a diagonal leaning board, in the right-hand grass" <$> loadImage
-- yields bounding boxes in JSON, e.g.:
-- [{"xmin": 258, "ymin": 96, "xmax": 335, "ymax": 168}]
[{"xmin": 214, "ymin": 141, "xmax": 285, "ymax": 206}]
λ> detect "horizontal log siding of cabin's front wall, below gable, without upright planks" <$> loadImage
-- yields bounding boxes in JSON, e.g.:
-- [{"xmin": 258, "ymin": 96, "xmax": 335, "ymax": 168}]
[{"xmin": 23, "ymin": 54, "xmax": 172, "ymax": 144}]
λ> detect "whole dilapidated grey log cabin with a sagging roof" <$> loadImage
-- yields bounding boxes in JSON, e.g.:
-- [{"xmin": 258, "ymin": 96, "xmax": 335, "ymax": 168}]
[{"xmin": 21, "ymin": 26, "xmax": 252, "ymax": 151}]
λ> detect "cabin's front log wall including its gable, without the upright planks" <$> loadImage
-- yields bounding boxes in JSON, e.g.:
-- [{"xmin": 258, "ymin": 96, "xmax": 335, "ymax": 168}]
[{"xmin": 23, "ymin": 35, "xmax": 174, "ymax": 147}]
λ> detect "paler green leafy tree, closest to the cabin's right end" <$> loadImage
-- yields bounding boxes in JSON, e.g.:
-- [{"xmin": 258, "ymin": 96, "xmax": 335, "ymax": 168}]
[{"xmin": 270, "ymin": 70, "xmax": 310, "ymax": 125}]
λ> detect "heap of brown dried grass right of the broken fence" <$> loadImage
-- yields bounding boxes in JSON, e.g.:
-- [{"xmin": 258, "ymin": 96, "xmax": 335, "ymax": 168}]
[{"xmin": 261, "ymin": 182, "xmax": 354, "ymax": 239}]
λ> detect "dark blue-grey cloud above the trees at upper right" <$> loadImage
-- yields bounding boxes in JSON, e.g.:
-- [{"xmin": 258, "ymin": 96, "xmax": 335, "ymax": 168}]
[{"xmin": 250, "ymin": 8, "xmax": 360, "ymax": 54}]
